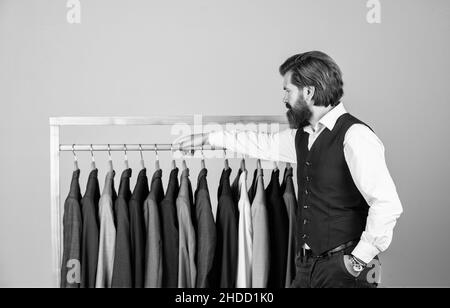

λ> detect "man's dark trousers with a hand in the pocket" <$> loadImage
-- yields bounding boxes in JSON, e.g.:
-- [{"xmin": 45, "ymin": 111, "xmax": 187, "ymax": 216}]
[{"xmin": 291, "ymin": 246, "xmax": 381, "ymax": 288}]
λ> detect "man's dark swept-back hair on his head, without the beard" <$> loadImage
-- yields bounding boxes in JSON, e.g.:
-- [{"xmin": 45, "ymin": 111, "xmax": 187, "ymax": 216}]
[{"xmin": 280, "ymin": 51, "xmax": 344, "ymax": 107}]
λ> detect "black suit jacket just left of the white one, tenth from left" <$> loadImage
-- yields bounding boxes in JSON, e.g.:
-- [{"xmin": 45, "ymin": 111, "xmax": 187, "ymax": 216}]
[{"xmin": 214, "ymin": 168, "xmax": 238, "ymax": 288}]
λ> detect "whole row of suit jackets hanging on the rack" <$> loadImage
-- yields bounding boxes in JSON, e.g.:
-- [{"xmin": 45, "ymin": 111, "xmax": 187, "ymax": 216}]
[{"xmin": 61, "ymin": 160, "xmax": 297, "ymax": 288}]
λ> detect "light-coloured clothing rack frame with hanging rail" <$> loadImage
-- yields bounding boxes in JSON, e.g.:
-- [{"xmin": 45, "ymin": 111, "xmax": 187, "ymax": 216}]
[{"xmin": 49, "ymin": 115, "xmax": 288, "ymax": 287}]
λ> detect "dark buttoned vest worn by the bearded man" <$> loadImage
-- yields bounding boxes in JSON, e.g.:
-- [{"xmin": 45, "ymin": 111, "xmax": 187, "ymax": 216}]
[{"xmin": 295, "ymin": 113, "xmax": 369, "ymax": 255}]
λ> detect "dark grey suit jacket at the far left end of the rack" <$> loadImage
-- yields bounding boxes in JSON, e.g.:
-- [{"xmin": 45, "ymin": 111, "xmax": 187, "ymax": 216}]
[{"xmin": 61, "ymin": 170, "xmax": 83, "ymax": 288}]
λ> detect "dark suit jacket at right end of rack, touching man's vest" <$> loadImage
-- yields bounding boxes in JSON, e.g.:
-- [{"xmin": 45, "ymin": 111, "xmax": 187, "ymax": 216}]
[{"xmin": 281, "ymin": 167, "xmax": 297, "ymax": 288}]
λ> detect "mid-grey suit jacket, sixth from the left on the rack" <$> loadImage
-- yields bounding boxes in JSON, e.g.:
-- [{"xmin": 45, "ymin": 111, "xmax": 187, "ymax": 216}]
[{"xmin": 144, "ymin": 169, "xmax": 164, "ymax": 288}]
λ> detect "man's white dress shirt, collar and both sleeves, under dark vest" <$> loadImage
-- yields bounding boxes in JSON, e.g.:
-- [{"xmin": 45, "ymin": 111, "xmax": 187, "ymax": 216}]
[{"xmin": 208, "ymin": 103, "xmax": 403, "ymax": 263}]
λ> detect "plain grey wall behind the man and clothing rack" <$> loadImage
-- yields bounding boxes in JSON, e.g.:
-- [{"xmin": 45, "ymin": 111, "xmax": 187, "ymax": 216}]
[{"xmin": 0, "ymin": 0, "xmax": 450, "ymax": 287}]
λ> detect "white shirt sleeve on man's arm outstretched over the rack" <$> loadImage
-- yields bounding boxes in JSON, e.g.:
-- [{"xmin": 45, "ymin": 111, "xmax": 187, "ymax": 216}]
[{"xmin": 208, "ymin": 129, "xmax": 297, "ymax": 163}]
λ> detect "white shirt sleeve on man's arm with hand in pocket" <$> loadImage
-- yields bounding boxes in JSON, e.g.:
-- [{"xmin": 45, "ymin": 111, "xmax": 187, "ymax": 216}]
[{"xmin": 344, "ymin": 124, "xmax": 403, "ymax": 263}]
